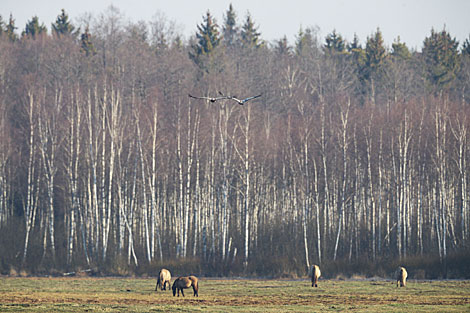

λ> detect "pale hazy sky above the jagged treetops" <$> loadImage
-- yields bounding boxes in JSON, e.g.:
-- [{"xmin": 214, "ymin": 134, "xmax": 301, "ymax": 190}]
[{"xmin": 0, "ymin": 0, "xmax": 470, "ymax": 50}]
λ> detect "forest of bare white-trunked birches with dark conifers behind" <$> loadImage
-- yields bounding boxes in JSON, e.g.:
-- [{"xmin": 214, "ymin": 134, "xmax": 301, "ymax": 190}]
[{"xmin": 0, "ymin": 5, "xmax": 470, "ymax": 277}]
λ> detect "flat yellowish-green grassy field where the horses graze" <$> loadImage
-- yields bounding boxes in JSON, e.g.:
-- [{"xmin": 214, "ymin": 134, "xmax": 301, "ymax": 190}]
[{"xmin": 0, "ymin": 277, "xmax": 470, "ymax": 312}]
